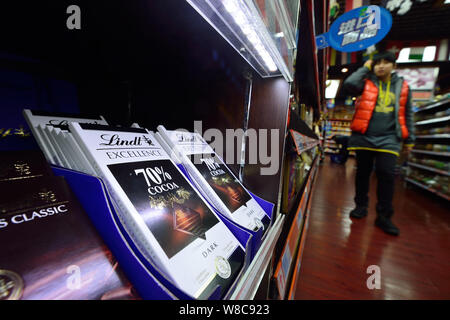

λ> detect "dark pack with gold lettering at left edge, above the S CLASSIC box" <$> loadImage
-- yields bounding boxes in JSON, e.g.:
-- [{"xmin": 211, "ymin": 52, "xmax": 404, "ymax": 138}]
[{"xmin": 0, "ymin": 150, "xmax": 53, "ymax": 181}]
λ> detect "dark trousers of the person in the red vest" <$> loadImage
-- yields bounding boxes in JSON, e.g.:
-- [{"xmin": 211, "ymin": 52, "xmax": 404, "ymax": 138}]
[{"xmin": 355, "ymin": 150, "xmax": 397, "ymax": 218}]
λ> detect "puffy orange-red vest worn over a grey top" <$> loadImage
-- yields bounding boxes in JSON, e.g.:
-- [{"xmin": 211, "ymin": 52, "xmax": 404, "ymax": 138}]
[{"xmin": 350, "ymin": 80, "xmax": 409, "ymax": 139}]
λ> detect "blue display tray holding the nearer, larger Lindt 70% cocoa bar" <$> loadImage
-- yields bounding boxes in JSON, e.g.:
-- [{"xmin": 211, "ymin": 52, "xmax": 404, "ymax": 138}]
[{"xmin": 52, "ymin": 166, "xmax": 273, "ymax": 300}]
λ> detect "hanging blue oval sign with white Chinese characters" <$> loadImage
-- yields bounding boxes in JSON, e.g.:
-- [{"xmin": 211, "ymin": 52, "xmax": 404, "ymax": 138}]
[{"xmin": 316, "ymin": 6, "xmax": 392, "ymax": 52}]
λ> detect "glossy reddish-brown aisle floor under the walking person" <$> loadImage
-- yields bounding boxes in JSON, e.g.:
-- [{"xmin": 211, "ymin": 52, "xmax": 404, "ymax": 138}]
[{"xmin": 295, "ymin": 157, "xmax": 450, "ymax": 299}]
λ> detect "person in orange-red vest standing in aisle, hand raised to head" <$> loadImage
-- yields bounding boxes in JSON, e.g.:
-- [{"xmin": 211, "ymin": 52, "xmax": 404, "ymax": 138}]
[{"xmin": 344, "ymin": 52, "xmax": 415, "ymax": 235}]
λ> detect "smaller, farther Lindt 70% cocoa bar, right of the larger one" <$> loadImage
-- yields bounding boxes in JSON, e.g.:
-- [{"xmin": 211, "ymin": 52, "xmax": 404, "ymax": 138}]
[{"xmin": 158, "ymin": 126, "xmax": 270, "ymax": 232}]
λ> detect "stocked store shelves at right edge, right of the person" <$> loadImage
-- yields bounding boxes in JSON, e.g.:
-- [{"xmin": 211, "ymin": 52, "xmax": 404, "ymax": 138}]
[{"xmin": 405, "ymin": 98, "xmax": 450, "ymax": 200}]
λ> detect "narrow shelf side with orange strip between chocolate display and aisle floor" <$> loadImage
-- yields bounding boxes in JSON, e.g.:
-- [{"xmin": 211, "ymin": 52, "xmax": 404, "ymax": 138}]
[{"xmin": 269, "ymin": 104, "xmax": 320, "ymax": 299}]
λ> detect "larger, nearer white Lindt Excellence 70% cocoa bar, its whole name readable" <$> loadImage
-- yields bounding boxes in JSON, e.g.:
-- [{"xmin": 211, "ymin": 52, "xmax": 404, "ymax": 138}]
[{"xmin": 69, "ymin": 122, "xmax": 245, "ymax": 299}]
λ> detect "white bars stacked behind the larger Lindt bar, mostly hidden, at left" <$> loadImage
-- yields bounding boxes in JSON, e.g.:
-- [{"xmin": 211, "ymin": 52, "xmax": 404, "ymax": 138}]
[{"xmin": 23, "ymin": 109, "xmax": 108, "ymax": 169}]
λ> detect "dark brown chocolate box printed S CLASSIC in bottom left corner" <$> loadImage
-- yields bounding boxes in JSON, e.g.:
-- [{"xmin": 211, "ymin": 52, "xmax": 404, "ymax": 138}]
[{"xmin": 0, "ymin": 177, "xmax": 138, "ymax": 300}]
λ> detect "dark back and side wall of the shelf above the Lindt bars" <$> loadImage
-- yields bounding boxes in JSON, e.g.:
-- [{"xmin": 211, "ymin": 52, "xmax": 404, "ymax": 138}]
[{"xmin": 0, "ymin": 0, "xmax": 289, "ymax": 203}]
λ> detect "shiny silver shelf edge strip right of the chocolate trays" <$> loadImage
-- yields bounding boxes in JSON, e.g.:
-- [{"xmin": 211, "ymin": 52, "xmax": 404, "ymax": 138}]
[{"xmin": 230, "ymin": 215, "xmax": 285, "ymax": 300}]
